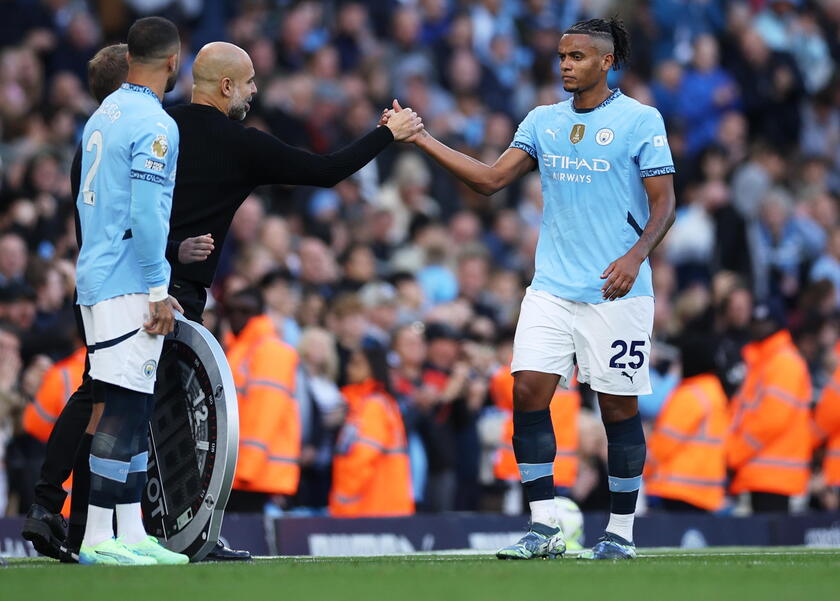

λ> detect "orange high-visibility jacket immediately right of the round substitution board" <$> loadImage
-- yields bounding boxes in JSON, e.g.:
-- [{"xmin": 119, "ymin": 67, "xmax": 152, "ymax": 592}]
[{"xmin": 227, "ymin": 315, "xmax": 301, "ymax": 495}]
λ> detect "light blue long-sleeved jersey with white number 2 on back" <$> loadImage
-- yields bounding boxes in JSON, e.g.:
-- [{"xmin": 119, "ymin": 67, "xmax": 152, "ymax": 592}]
[{"xmin": 76, "ymin": 83, "xmax": 179, "ymax": 305}]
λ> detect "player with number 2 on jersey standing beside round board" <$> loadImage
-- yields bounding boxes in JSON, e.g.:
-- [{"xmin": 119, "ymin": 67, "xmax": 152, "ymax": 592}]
[{"xmin": 76, "ymin": 17, "xmax": 189, "ymax": 565}]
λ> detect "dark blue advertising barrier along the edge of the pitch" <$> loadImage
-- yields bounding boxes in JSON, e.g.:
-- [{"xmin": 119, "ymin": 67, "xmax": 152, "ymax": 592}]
[{"xmin": 0, "ymin": 513, "xmax": 840, "ymax": 557}]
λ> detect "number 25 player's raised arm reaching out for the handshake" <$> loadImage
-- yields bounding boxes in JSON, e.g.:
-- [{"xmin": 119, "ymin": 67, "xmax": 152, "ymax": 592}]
[{"xmin": 383, "ymin": 100, "xmax": 536, "ymax": 196}]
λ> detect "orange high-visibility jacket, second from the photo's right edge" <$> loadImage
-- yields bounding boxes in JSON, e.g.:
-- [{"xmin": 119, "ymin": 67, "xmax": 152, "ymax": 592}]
[{"xmin": 726, "ymin": 330, "xmax": 813, "ymax": 495}]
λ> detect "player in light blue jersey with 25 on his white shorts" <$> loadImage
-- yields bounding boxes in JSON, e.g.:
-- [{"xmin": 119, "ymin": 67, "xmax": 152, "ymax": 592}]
[{"xmin": 394, "ymin": 19, "xmax": 674, "ymax": 559}]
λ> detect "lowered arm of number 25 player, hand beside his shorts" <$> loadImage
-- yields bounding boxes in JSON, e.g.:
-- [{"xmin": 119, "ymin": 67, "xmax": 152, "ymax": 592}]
[{"xmin": 601, "ymin": 174, "xmax": 675, "ymax": 300}]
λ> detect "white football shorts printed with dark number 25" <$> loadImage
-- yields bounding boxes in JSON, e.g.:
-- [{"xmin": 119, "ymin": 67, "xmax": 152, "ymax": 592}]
[{"xmin": 511, "ymin": 287, "xmax": 653, "ymax": 396}]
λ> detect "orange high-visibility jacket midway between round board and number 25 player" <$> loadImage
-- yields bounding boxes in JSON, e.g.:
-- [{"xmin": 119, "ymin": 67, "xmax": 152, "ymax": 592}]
[{"xmin": 329, "ymin": 380, "xmax": 414, "ymax": 517}]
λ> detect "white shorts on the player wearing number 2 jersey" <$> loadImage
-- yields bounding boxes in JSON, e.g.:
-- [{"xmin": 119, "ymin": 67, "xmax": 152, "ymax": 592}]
[{"xmin": 80, "ymin": 294, "xmax": 164, "ymax": 394}]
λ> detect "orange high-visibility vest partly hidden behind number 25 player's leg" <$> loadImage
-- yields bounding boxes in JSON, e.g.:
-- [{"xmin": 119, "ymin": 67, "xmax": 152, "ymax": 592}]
[{"xmin": 490, "ymin": 366, "xmax": 580, "ymax": 487}]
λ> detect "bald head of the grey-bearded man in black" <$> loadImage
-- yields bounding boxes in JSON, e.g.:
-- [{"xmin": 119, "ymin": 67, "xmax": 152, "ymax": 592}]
[{"xmin": 193, "ymin": 42, "xmax": 257, "ymax": 121}]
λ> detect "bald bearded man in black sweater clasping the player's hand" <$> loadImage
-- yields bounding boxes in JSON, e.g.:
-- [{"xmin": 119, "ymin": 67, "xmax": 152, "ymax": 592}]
[{"xmin": 23, "ymin": 42, "xmax": 422, "ymax": 559}]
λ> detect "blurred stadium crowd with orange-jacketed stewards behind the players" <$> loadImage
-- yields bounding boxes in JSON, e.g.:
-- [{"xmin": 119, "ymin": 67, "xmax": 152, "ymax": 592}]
[{"xmin": 0, "ymin": 0, "xmax": 840, "ymax": 515}]
